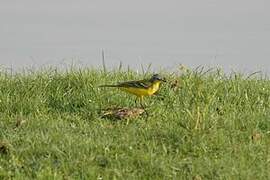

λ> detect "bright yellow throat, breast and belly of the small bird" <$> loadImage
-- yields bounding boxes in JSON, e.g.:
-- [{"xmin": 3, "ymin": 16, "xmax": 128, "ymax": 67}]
[{"xmin": 119, "ymin": 81, "xmax": 160, "ymax": 98}]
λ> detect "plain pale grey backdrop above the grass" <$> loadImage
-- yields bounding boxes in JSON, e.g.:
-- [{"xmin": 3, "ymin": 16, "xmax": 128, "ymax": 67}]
[{"xmin": 0, "ymin": 0, "xmax": 270, "ymax": 72}]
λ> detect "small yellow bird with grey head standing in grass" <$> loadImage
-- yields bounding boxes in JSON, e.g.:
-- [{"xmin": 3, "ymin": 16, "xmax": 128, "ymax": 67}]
[{"xmin": 99, "ymin": 74, "xmax": 166, "ymax": 106}]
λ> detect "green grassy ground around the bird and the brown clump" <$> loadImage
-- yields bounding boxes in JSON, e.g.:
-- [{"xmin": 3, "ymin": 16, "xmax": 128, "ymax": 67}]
[{"xmin": 0, "ymin": 69, "xmax": 270, "ymax": 180}]
